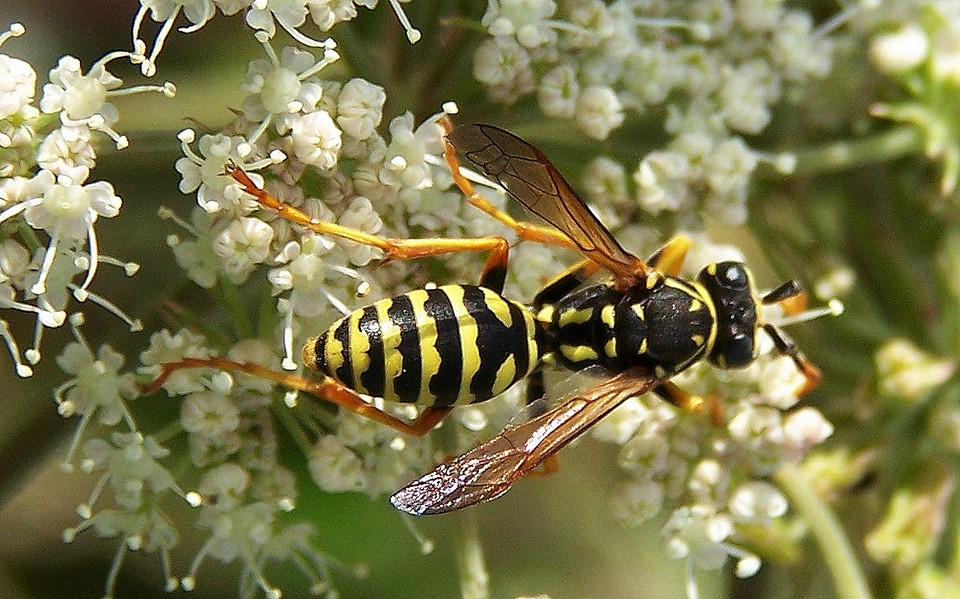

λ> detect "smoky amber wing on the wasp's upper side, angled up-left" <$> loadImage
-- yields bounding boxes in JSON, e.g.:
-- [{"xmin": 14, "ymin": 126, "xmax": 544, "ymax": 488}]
[{"xmin": 447, "ymin": 124, "xmax": 647, "ymax": 278}]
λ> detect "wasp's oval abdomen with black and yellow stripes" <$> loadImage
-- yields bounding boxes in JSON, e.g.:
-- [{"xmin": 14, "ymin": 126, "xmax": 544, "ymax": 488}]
[{"xmin": 303, "ymin": 285, "xmax": 543, "ymax": 405}]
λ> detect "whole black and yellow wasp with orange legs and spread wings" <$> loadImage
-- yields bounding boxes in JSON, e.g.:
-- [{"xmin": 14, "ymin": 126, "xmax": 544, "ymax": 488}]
[{"xmin": 148, "ymin": 117, "xmax": 838, "ymax": 515}]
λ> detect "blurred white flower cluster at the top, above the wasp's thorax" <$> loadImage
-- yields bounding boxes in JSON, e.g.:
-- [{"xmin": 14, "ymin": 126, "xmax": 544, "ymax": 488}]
[{"xmin": 474, "ymin": 0, "xmax": 833, "ymax": 226}]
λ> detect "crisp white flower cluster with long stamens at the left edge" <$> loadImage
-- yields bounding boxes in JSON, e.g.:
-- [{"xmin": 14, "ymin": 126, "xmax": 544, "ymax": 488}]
[{"xmin": 0, "ymin": 24, "xmax": 175, "ymax": 376}]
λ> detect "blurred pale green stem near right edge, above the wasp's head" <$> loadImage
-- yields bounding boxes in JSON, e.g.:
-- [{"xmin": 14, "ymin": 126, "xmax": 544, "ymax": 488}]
[{"xmin": 791, "ymin": 125, "xmax": 924, "ymax": 175}]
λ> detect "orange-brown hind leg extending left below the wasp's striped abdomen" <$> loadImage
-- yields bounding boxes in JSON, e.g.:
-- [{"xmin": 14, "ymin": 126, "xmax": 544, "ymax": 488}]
[{"xmin": 142, "ymin": 358, "xmax": 453, "ymax": 437}]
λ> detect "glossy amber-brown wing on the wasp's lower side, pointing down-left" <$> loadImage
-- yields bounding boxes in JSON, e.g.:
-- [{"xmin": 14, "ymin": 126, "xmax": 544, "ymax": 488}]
[{"xmin": 390, "ymin": 369, "xmax": 664, "ymax": 516}]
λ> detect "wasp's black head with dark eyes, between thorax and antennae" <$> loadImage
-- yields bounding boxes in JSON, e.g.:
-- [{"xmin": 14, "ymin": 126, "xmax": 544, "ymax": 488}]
[{"xmin": 697, "ymin": 262, "xmax": 757, "ymax": 368}]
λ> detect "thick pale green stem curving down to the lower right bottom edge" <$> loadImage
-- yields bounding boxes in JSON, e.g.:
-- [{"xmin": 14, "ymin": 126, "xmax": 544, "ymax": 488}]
[{"xmin": 774, "ymin": 464, "xmax": 872, "ymax": 599}]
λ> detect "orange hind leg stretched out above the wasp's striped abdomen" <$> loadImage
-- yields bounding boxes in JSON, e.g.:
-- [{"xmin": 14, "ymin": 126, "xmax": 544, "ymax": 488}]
[{"xmin": 225, "ymin": 165, "xmax": 510, "ymax": 272}]
